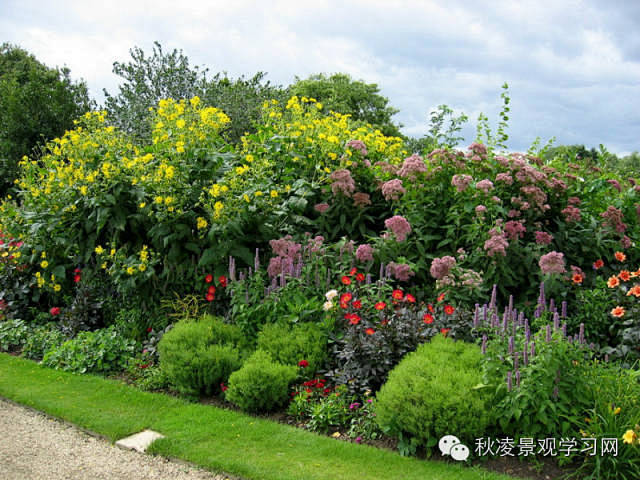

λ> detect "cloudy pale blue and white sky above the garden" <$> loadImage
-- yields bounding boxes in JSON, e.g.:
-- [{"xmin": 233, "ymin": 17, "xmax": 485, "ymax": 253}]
[{"xmin": 0, "ymin": 0, "xmax": 640, "ymax": 153}]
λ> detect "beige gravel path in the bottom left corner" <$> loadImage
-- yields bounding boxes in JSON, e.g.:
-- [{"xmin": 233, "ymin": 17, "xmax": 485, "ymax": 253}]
[{"xmin": 0, "ymin": 399, "xmax": 228, "ymax": 480}]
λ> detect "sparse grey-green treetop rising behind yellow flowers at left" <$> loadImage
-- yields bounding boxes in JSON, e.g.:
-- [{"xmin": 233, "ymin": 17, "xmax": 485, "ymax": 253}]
[{"xmin": 104, "ymin": 42, "xmax": 207, "ymax": 141}]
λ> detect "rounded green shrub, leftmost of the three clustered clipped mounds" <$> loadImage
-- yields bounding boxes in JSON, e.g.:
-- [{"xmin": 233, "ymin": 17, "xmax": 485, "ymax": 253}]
[{"xmin": 158, "ymin": 315, "xmax": 244, "ymax": 395}]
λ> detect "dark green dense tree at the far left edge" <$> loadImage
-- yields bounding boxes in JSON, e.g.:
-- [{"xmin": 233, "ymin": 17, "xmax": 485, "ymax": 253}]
[{"xmin": 0, "ymin": 43, "xmax": 93, "ymax": 196}]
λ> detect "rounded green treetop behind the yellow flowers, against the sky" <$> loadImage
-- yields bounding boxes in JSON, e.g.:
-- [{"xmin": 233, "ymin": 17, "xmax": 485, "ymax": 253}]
[{"xmin": 289, "ymin": 73, "xmax": 403, "ymax": 137}]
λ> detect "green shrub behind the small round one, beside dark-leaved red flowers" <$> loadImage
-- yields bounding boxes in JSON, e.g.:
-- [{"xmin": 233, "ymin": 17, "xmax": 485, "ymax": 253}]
[{"xmin": 258, "ymin": 323, "xmax": 327, "ymax": 376}]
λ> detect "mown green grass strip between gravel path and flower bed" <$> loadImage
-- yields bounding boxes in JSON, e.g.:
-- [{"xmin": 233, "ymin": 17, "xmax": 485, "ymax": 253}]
[{"xmin": 0, "ymin": 354, "xmax": 512, "ymax": 480}]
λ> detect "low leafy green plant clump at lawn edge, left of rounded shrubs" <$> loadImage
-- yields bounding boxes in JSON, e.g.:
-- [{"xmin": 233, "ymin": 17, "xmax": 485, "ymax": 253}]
[{"xmin": 42, "ymin": 327, "xmax": 136, "ymax": 374}]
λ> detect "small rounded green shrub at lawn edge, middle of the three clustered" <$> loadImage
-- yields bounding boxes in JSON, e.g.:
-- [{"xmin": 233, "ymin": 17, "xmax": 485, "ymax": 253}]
[{"xmin": 226, "ymin": 350, "xmax": 298, "ymax": 412}]
